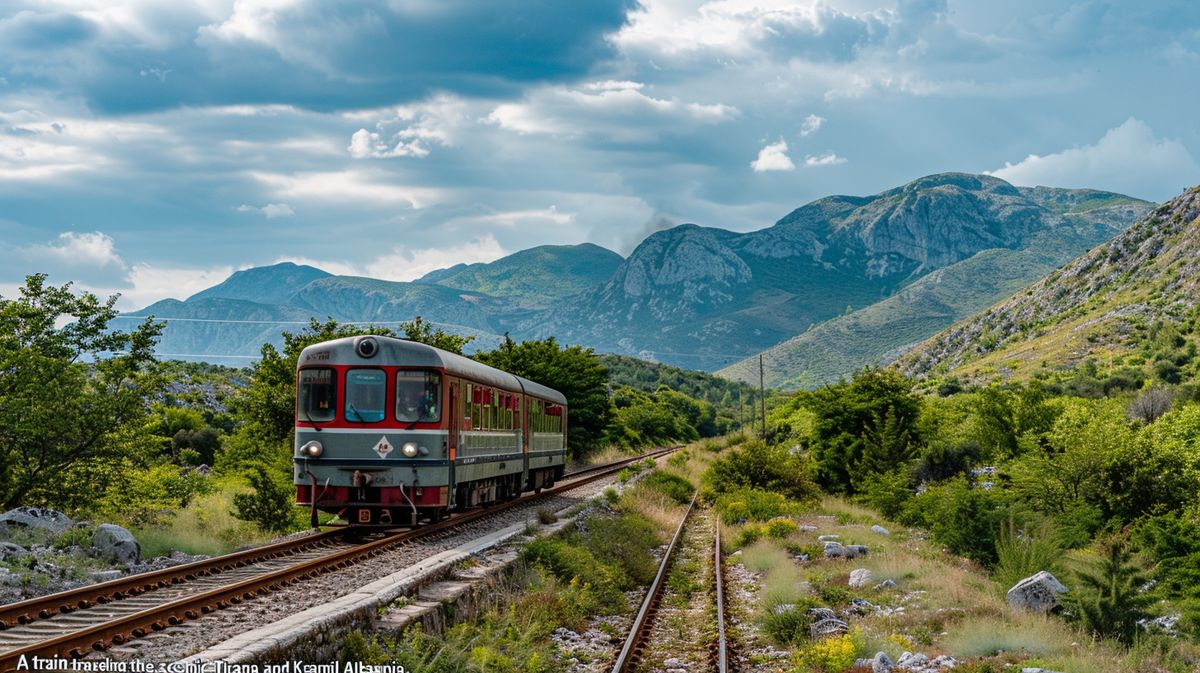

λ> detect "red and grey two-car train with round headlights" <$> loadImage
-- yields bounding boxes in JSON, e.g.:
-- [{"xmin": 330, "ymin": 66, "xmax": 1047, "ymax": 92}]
[{"xmin": 294, "ymin": 335, "xmax": 568, "ymax": 527}]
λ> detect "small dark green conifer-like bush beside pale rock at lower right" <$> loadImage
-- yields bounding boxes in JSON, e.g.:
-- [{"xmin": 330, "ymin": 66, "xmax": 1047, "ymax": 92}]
[{"xmin": 1068, "ymin": 536, "xmax": 1153, "ymax": 645}]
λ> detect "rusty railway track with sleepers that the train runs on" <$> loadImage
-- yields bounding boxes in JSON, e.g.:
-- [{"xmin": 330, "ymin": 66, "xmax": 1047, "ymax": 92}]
[{"xmin": 0, "ymin": 449, "xmax": 673, "ymax": 672}]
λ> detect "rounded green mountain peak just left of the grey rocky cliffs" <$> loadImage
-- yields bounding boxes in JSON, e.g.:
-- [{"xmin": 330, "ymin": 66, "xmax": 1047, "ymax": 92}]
[{"xmin": 416, "ymin": 244, "xmax": 622, "ymax": 305}]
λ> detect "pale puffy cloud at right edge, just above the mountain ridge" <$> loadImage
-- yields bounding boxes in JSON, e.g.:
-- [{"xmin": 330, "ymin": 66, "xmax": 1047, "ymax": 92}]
[{"xmin": 989, "ymin": 116, "xmax": 1200, "ymax": 200}]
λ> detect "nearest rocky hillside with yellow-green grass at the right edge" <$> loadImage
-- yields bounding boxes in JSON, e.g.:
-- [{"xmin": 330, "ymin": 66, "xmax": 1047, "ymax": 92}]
[{"xmin": 898, "ymin": 187, "xmax": 1200, "ymax": 379}]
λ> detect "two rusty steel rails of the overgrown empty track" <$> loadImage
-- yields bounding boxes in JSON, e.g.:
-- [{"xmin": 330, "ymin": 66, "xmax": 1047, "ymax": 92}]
[{"xmin": 612, "ymin": 493, "xmax": 730, "ymax": 673}]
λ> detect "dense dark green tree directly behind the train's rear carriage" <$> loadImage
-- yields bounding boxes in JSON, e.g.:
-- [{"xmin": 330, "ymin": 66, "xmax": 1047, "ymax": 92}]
[{"xmin": 475, "ymin": 337, "xmax": 613, "ymax": 456}]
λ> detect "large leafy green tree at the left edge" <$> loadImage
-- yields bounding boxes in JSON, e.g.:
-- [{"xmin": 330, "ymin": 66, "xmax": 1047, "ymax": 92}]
[{"xmin": 0, "ymin": 274, "xmax": 162, "ymax": 509}]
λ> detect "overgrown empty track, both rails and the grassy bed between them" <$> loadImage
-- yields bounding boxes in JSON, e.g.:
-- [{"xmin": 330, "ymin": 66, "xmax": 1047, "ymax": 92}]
[{"xmin": 612, "ymin": 497, "xmax": 730, "ymax": 673}]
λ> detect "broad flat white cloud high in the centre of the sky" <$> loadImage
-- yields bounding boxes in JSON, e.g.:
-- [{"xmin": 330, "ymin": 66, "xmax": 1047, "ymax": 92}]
[{"xmin": 485, "ymin": 80, "xmax": 740, "ymax": 142}]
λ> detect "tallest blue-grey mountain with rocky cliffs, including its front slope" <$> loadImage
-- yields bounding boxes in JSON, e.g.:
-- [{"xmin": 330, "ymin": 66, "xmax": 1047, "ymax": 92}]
[{"xmin": 540, "ymin": 173, "xmax": 1151, "ymax": 369}]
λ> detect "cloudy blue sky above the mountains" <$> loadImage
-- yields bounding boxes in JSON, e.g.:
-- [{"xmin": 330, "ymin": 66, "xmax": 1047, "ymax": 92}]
[{"xmin": 0, "ymin": 0, "xmax": 1200, "ymax": 310}]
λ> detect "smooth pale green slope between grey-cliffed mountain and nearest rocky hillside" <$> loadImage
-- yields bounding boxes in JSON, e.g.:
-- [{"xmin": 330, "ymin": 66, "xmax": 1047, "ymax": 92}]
[{"xmin": 718, "ymin": 187, "xmax": 1152, "ymax": 389}]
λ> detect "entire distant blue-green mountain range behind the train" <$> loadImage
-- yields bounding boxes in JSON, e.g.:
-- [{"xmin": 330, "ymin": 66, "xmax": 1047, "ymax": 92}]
[{"xmin": 119, "ymin": 173, "xmax": 1153, "ymax": 387}]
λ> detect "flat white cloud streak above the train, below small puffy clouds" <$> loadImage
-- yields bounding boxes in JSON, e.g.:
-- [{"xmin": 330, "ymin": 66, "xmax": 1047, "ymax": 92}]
[{"xmin": 250, "ymin": 170, "xmax": 444, "ymax": 208}]
